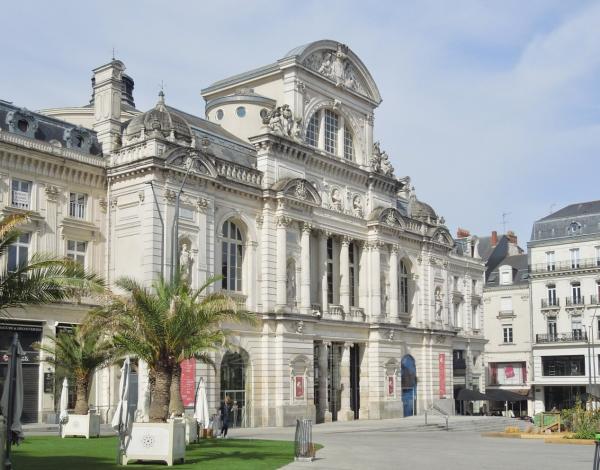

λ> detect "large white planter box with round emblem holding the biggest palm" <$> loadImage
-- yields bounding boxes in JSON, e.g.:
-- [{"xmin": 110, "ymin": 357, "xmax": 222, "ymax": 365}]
[{"xmin": 123, "ymin": 419, "xmax": 185, "ymax": 466}]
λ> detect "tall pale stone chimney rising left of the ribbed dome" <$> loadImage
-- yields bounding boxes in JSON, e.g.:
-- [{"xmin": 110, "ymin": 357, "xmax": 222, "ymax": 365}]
[{"xmin": 93, "ymin": 60, "xmax": 125, "ymax": 155}]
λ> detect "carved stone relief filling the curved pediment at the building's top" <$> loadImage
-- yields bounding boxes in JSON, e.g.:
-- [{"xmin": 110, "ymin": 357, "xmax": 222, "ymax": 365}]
[{"xmin": 302, "ymin": 44, "xmax": 368, "ymax": 96}]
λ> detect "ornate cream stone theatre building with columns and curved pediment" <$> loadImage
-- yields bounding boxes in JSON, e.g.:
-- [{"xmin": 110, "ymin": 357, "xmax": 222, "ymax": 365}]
[{"xmin": 0, "ymin": 40, "xmax": 485, "ymax": 426}]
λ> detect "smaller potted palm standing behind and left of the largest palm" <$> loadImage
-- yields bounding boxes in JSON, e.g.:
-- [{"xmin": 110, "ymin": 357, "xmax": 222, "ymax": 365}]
[{"xmin": 34, "ymin": 327, "xmax": 113, "ymax": 415}]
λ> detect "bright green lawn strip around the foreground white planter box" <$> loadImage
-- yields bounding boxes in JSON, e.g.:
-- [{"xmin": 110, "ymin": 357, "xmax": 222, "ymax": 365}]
[{"xmin": 12, "ymin": 436, "xmax": 312, "ymax": 470}]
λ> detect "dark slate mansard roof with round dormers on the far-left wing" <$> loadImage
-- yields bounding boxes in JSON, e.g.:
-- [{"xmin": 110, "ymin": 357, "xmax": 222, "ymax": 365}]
[{"xmin": 0, "ymin": 100, "xmax": 102, "ymax": 156}]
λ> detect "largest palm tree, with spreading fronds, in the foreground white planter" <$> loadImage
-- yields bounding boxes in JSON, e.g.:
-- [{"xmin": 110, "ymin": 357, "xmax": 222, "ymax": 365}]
[{"xmin": 91, "ymin": 276, "xmax": 255, "ymax": 422}]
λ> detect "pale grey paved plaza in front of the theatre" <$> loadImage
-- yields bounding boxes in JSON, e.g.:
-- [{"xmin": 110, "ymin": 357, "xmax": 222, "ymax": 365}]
[{"xmin": 232, "ymin": 416, "xmax": 594, "ymax": 470}]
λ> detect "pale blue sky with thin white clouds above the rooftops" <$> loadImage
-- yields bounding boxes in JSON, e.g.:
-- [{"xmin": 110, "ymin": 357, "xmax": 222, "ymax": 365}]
[{"xmin": 0, "ymin": 0, "xmax": 600, "ymax": 245}]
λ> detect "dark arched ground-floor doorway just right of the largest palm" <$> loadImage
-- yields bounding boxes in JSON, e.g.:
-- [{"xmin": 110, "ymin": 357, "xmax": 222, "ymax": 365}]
[{"xmin": 221, "ymin": 352, "xmax": 247, "ymax": 426}]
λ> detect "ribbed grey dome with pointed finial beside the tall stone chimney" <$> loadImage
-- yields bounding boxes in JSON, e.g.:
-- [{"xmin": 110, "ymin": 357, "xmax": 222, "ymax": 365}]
[{"xmin": 125, "ymin": 91, "xmax": 192, "ymax": 142}]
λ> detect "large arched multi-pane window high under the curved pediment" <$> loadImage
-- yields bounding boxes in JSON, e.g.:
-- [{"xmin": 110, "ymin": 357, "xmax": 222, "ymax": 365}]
[{"xmin": 305, "ymin": 109, "xmax": 355, "ymax": 161}]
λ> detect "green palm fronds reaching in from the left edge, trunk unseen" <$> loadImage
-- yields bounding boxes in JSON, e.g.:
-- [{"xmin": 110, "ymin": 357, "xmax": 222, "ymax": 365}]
[{"xmin": 0, "ymin": 213, "xmax": 104, "ymax": 311}]
